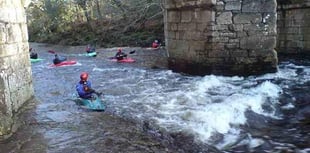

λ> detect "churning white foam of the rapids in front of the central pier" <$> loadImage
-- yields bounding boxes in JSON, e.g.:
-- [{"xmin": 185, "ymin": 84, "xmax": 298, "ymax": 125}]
[{"xmin": 93, "ymin": 61, "xmax": 310, "ymax": 149}]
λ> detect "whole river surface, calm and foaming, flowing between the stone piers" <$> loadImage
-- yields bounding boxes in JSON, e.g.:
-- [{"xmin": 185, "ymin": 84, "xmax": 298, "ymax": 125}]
[{"xmin": 0, "ymin": 43, "xmax": 310, "ymax": 153}]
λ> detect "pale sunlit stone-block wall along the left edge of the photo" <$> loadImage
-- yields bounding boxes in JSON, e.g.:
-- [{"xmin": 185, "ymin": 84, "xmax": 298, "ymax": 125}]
[{"xmin": 0, "ymin": 0, "xmax": 33, "ymax": 136}]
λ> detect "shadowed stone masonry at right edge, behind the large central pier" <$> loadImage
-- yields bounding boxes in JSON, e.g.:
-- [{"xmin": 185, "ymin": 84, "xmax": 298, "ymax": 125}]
[{"xmin": 277, "ymin": 0, "xmax": 310, "ymax": 55}]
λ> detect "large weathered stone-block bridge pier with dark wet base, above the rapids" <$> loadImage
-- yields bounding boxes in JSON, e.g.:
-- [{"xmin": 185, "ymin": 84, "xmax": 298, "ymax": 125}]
[{"xmin": 164, "ymin": 0, "xmax": 277, "ymax": 75}]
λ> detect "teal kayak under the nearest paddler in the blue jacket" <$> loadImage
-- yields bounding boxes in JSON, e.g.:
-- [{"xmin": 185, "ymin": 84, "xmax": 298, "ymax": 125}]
[{"xmin": 77, "ymin": 94, "xmax": 105, "ymax": 111}]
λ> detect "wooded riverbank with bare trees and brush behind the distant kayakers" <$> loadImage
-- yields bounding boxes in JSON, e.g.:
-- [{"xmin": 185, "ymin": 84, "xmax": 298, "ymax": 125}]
[{"xmin": 26, "ymin": 0, "xmax": 164, "ymax": 47}]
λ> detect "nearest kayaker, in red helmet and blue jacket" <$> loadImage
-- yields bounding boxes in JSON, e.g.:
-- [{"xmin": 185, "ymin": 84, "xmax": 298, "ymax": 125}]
[{"xmin": 76, "ymin": 72, "xmax": 100, "ymax": 99}]
